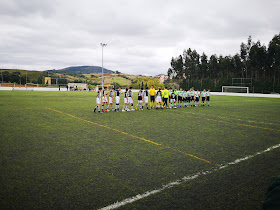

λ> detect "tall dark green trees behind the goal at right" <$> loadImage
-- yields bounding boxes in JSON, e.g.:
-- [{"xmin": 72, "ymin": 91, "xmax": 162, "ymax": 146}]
[{"xmin": 167, "ymin": 33, "xmax": 280, "ymax": 93}]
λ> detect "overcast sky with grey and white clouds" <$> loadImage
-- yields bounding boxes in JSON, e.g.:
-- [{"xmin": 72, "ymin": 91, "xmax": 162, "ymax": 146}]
[{"xmin": 0, "ymin": 0, "xmax": 280, "ymax": 75}]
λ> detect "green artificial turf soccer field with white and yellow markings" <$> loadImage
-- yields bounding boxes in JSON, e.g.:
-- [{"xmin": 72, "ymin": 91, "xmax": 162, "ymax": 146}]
[{"xmin": 0, "ymin": 91, "xmax": 280, "ymax": 209}]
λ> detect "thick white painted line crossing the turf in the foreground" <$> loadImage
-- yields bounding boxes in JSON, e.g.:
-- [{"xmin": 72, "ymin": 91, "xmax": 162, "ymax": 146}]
[{"xmin": 101, "ymin": 144, "xmax": 280, "ymax": 210}]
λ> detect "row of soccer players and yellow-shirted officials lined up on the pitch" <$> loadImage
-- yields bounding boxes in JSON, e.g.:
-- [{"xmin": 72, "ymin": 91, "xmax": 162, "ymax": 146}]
[{"xmin": 93, "ymin": 85, "xmax": 210, "ymax": 113}]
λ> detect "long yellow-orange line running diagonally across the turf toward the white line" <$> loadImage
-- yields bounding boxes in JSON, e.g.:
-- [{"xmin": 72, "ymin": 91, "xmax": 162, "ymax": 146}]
[{"xmin": 47, "ymin": 108, "xmax": 220, "ymax": 166}]
